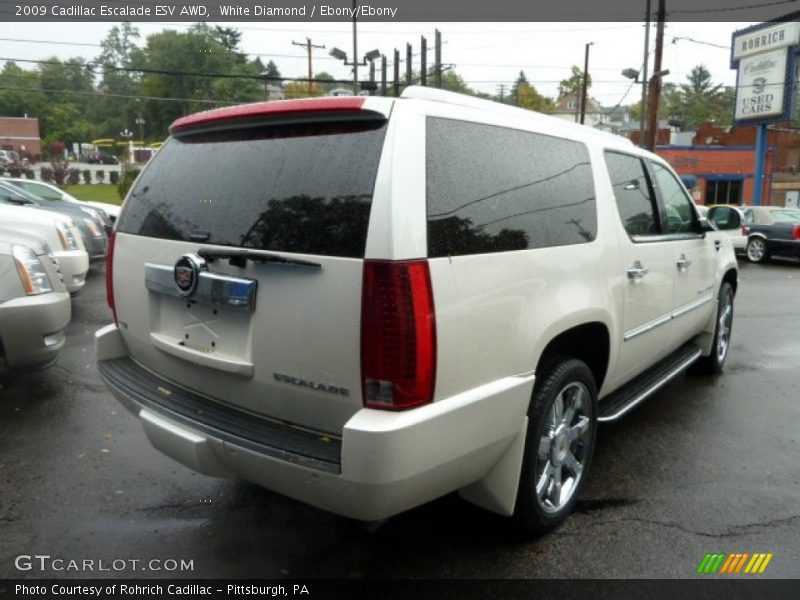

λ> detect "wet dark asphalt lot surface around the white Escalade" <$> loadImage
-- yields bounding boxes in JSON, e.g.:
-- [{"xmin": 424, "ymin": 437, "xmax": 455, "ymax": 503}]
[{"xmin": 0, "ymin": 261, "xmax": 800, "ymax": 578}]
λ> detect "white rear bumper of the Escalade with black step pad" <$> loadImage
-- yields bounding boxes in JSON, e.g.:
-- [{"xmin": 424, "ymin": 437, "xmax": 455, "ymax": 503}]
[{"xmin": 96, "ymin": 325, "xmax": 533, "ymax": 521}]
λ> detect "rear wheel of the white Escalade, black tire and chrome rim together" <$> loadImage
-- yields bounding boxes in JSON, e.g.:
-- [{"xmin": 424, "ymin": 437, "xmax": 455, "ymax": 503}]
[{"xmin": 512, "ymin": 357, "xmax": 597, "ymax": 537}]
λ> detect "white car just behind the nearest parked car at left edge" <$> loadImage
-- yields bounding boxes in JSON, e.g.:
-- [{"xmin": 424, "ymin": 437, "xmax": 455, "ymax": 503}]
[{"xmin": 0, "ymin": 205, "xmax": 89, "ymax": 294}]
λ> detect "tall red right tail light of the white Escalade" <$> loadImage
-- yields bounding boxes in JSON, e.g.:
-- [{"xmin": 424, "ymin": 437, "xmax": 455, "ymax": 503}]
[{"xmin": 361, "ymin": 260, "xmax": 436, "ymax": 410}]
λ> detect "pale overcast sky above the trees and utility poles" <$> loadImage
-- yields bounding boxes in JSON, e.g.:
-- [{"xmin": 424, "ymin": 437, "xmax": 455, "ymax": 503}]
[{"xmin": 0, "ymin": 22, "xmax": 752, "ymax": 106}]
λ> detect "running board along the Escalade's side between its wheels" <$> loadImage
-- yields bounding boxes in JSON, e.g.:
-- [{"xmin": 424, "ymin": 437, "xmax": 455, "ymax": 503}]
[{"xmin": 597, "ymin": 343, "xmax": 702, "ymax": 423}]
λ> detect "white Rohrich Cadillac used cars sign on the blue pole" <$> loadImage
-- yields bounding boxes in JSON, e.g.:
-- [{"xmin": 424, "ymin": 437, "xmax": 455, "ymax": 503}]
[{"xmin": 731, "ymin": 19, "xmax": 800, "ymax": 124}]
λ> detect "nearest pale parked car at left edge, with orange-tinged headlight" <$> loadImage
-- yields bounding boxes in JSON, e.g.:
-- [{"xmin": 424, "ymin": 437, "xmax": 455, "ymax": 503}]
[{"xmin": 0, "ymin": 232, "xmax": 71, "ymax": 376}]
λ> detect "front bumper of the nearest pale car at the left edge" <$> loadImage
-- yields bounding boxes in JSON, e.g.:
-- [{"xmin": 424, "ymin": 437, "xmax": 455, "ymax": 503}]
[{"xmin": 0, "ymin": 292, "xmax": 72, "ymax": 369}]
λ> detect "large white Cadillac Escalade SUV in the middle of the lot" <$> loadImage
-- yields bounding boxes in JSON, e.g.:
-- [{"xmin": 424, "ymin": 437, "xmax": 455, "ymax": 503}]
[{"xmin": 97, "ymin": 87, "xmax": 737, "ymax": 533}]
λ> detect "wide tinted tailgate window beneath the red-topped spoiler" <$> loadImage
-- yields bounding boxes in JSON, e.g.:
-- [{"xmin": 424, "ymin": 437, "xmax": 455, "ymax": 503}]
[{"xmin": 119, "ymin": 120, "xmax": 386, "ymax": 257}]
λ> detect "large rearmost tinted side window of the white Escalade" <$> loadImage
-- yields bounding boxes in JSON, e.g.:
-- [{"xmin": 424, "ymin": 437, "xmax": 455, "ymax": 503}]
[{"xmin": 426, "ymin": 117, "xmax": 597, "ymax": 257}]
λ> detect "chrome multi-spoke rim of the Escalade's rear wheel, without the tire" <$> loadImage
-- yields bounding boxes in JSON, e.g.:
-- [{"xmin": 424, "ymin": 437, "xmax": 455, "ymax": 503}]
[{"xmin": 534, "ymin": 382, "xmax": 592, "ymax": 513}]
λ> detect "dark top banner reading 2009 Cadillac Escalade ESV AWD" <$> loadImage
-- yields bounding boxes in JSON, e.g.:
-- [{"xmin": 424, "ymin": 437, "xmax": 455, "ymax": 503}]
[{"xmin": 0, "ymin": 0, "xmax": 799, "ymax": 22}]
